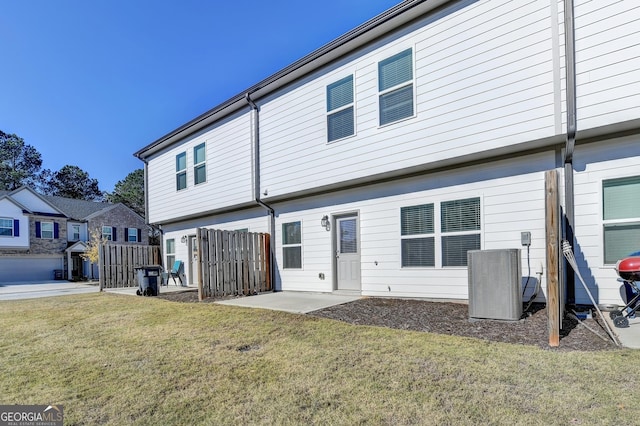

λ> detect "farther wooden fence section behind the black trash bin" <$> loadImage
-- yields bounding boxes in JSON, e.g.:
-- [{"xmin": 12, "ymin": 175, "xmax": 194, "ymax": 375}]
[{"xmin": 98, "ymin": 244, "xmax": 162, "ymax": 290}]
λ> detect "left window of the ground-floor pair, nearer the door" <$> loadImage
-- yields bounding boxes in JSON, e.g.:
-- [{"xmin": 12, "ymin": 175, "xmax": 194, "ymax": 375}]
[{"xmin": 400, "ymin": 204, "xmax": 436, "ymax": 268}]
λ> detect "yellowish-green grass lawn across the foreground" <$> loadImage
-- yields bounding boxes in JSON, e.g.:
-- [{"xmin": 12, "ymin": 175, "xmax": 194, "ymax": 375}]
[{"xmin": 0, "ymin": 294, "xmax": 640, "ymax": 425}]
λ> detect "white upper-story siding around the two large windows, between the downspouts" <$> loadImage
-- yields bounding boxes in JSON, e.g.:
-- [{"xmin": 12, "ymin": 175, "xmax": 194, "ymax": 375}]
[{"xmin": 260, "ymin": 0, "xmax": 562, "ymax": 197}]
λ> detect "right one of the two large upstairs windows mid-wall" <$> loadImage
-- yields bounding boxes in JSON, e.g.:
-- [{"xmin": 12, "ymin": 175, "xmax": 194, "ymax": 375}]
[{"xmin": 378, "ymin": 49, "xmax": 414, "ymax": 126}]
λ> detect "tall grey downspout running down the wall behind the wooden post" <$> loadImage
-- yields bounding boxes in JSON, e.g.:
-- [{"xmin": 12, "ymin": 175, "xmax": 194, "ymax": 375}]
[{"xmin": 564, "ymin": 0, "xmax": 578, "ymax": 304}]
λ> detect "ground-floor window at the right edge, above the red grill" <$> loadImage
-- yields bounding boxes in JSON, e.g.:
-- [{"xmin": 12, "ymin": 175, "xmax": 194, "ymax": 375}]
[{"xmin": 602, "ymin": 176, "xmax": 640, "ymax": 265}]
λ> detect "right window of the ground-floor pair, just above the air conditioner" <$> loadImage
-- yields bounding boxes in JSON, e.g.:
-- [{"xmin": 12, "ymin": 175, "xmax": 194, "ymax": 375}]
[{"xmin": 440, "ymin": 198, "xmax": 480, "ymax": 266}]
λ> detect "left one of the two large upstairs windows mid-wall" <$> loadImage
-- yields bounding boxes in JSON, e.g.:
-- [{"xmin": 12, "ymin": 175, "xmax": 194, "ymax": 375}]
[{"xmin": 327, "ymin": 75, "xmax": 355, "ymax": 142}]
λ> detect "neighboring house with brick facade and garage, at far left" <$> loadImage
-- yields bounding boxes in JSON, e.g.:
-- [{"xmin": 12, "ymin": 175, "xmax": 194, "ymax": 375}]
[{"xmin": 0, "ymin": 187, "xmax": 149, "ymax": 282}]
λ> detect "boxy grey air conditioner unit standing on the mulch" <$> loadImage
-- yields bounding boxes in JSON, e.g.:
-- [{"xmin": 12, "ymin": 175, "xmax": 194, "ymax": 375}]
[{"xmin": 467, "ymin": 249, "xmax": 522, "ymax": 321}]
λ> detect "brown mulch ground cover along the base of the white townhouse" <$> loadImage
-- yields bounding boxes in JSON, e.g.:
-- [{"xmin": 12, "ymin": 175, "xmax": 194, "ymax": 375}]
[{"xmin": 158, "ymin": 291, "xmax": 617, "ymax": 351}]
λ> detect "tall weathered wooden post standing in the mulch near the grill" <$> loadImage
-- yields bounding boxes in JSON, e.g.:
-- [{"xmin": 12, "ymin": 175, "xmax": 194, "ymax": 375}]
[{"xmin": 544, "ymin": 170, "xmax": 562, "ymax": 347}]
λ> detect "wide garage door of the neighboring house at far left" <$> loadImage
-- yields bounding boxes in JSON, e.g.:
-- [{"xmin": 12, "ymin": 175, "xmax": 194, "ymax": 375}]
[{"xmin": 0, "ymin": 257, "xmax": 64, "ymax": 283}]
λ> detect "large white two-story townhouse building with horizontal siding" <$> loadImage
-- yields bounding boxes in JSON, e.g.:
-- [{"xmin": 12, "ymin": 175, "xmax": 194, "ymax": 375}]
[{"xmin": 135, "ymin": 0, "xmax": 640, "ymax": 303}]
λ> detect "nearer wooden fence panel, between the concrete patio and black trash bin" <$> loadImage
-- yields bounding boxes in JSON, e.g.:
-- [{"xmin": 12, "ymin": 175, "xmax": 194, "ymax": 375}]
[{"xmin": 196, "ymin": 228, "xmax": 271, "ymax": 300}]
